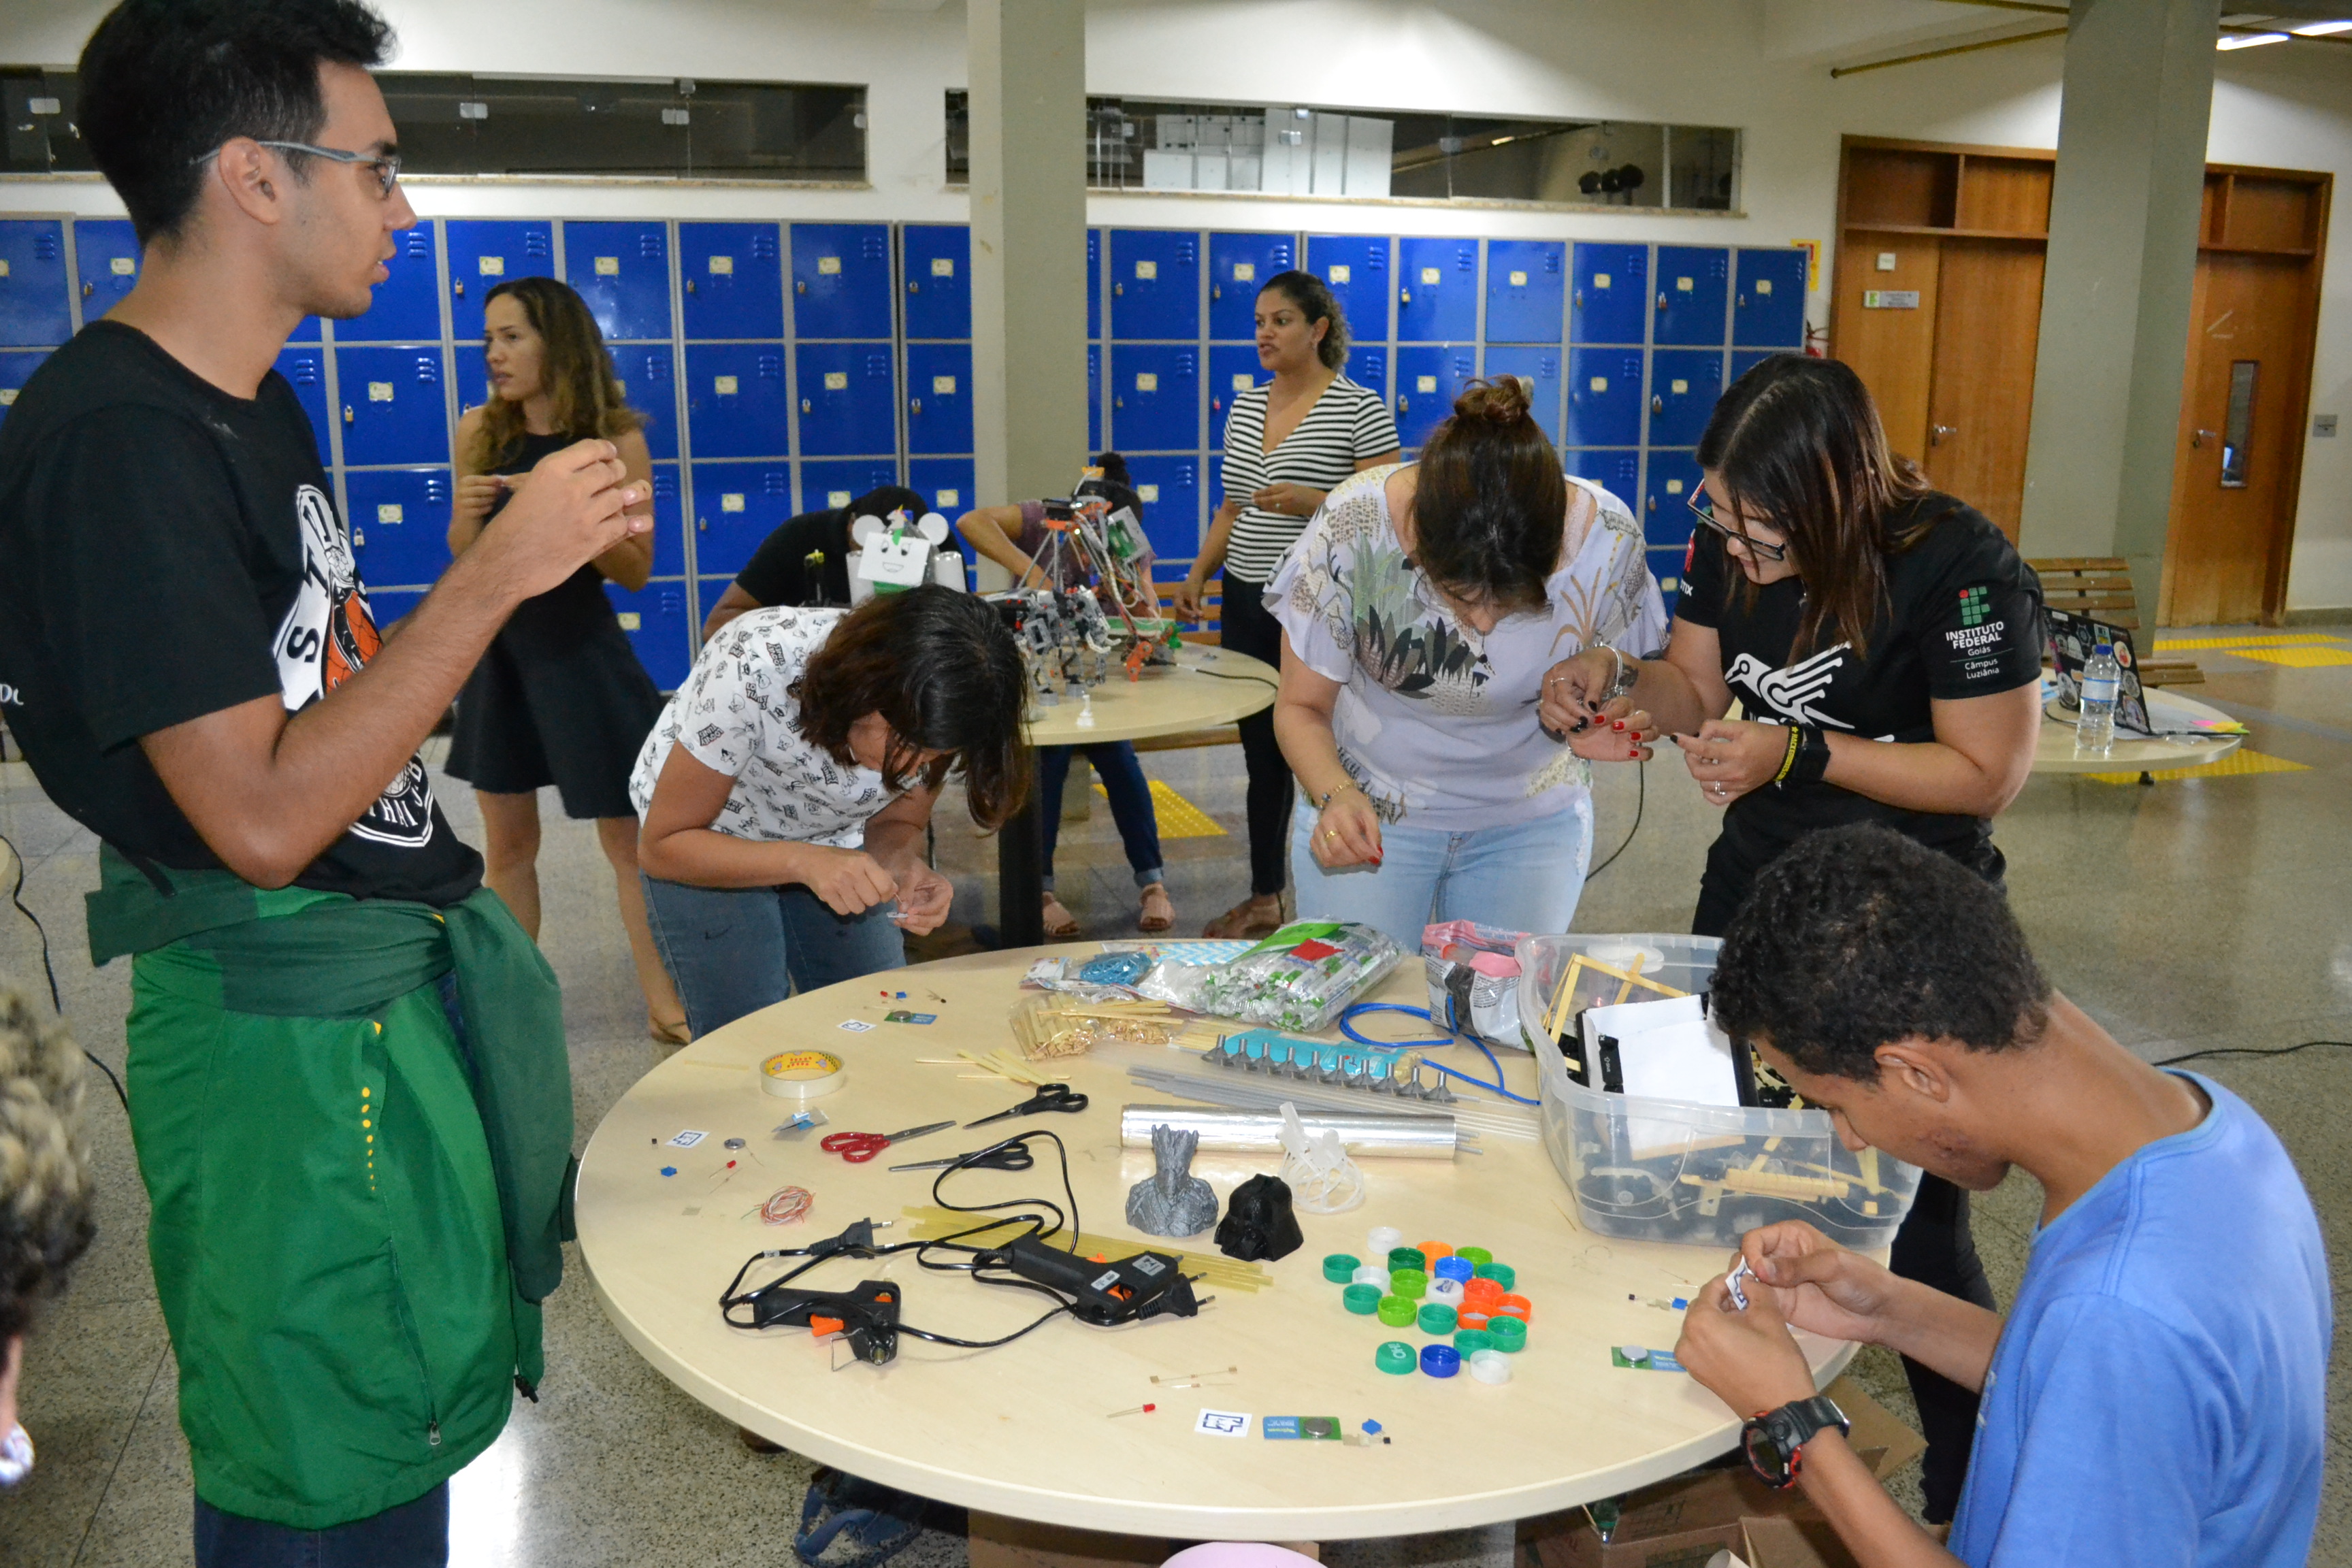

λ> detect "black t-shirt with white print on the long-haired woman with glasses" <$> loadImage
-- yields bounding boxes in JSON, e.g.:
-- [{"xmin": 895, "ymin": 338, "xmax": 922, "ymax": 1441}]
[{"xmin": 1675, "ymin": 491, "xmax": 2042, "ymax": 875}]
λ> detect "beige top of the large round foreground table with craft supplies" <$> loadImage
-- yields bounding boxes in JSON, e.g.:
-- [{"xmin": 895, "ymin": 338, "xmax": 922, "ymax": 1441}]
[{"xmin": 578, "ymin": 945, "xmax": 1851, "ymax": 1540}]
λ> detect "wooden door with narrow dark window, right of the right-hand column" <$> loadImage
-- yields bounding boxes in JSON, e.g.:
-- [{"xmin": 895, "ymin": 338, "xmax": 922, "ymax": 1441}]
[{"xmin": 2159, "ymin": 252, "xmax": 2312, "ymax": 625}]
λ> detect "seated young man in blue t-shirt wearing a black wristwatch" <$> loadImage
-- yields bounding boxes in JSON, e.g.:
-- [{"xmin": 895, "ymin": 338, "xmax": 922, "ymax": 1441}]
[{"xmin": 1675, "ymin": 828, "xmax": 2333, "ymax": 1568}]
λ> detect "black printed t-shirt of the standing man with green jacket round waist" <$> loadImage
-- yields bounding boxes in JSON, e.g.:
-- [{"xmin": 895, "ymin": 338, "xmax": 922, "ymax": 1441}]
[{"xmin": 0, "ymin": 322, "xmax": 482, "ymax": 905}]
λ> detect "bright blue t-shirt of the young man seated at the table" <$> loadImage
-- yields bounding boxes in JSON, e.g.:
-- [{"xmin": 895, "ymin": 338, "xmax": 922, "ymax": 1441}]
[{"xmin": 1950, "ymin": 1075, "xmax": 2333, "ymax": 1568}]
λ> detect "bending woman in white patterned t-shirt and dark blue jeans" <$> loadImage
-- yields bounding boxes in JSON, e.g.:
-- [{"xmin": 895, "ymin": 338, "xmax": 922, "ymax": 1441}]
[{"xmin": 630, "ymin": 585, "xmax": 1028, "ymax": 1036}]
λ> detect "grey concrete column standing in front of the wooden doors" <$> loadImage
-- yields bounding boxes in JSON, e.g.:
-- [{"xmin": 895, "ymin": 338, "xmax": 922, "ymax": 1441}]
[{"xmin": 2018, "ymin": 0, "xmax": 2220, "ymax": 616}]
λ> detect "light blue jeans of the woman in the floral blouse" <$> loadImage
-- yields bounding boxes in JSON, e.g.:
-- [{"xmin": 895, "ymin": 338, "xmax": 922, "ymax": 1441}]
[{"xmin": 1291, "ymin": 795, "xmax": 1592, "ymax": 954}]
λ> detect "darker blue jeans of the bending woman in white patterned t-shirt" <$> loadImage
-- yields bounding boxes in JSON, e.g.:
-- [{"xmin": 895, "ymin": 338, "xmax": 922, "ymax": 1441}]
[{"xmin": 640, "ymin": 872, "xmax": 906, "ymax": 1039}]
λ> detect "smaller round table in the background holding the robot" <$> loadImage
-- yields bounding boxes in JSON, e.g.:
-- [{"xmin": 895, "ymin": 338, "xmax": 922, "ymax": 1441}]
[{"xmin": 997, "ymin": 644, "xmax": 1279, "ymax": 947}]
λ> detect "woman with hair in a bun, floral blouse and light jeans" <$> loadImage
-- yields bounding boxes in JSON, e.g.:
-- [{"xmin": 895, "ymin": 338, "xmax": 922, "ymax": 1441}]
[{"xmin": 1265, "ymin": 376, "xmax": 1665, "ymax": 952}]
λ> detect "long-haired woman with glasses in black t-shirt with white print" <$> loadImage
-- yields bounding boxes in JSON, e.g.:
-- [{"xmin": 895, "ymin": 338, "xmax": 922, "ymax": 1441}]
[{"xmin": 1543, "ymin": 355, "xmax": 2042, "ymax": 1523}]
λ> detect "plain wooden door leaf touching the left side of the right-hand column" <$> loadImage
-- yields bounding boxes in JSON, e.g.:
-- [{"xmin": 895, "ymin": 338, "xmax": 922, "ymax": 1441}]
[{"xmin": 1922, "ymin": 240, "xmax": 2044, "ymax": 543}]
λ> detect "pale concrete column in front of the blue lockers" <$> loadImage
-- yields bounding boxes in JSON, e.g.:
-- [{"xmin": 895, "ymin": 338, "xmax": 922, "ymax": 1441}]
[{"xmin": 966, "ymin": 0, "xmax": 1089, "ymax": 506}]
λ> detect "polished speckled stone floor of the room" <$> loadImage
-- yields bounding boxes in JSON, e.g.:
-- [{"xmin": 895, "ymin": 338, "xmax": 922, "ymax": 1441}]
[{"xmin": 0, "ymin": 627, "xmax": 2352, "ymax": 1568}]
